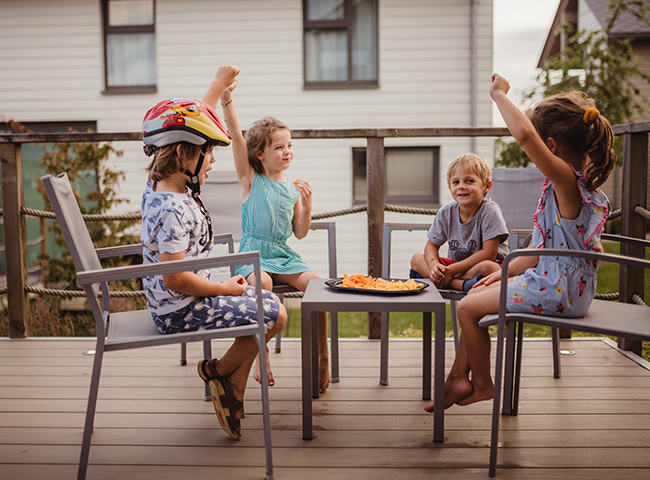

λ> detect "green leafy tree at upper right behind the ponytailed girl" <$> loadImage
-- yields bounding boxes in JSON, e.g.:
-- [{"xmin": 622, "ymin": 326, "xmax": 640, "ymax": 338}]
[{"xmin": 495, "ymin": 0, "xmax": 650, "ymax": 167}]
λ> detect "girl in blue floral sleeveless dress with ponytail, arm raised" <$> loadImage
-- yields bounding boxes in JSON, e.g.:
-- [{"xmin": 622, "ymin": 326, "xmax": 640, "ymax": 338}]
[{"xmin": 425, "ymin": 74, "xmax": 616, "ymax": 411}]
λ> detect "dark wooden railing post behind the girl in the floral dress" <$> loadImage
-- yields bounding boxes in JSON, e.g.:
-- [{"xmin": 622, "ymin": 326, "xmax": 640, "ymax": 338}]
[{"xmin": 618, "ymin": 132, "xmax": 648, "ymax": 355}]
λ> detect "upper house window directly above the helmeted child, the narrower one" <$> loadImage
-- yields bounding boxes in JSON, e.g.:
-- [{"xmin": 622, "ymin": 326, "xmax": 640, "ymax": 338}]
[{"xmin": 102, "ymin": 0, "xmax": 156, "ymax": 93}]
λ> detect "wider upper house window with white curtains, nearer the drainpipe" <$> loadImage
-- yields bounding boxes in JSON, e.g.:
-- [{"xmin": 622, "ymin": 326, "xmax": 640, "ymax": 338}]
[{"xmin": 303, "ymin": 0, "xmax": 378, "ymax": 88}]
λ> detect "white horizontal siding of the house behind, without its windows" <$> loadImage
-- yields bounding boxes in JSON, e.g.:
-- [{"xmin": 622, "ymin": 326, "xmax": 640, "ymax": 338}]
[{"xmin": 0, "ymin": 0, "xmax": 493, "ymax": 276}]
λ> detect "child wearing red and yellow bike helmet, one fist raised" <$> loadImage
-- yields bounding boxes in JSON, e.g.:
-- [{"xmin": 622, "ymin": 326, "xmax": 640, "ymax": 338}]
[{"xmin": 141, "ymin": 66, "xmax": 287, "ymax": 439}]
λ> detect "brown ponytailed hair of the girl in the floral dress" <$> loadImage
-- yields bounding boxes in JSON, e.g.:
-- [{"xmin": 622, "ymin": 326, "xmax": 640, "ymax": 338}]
[{"xmin": 527, "ymin": 91, "xmax": 616, "ymax": 191}]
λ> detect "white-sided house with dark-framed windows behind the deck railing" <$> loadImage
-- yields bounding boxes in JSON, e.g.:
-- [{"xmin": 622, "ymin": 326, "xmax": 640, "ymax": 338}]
[{"xmin": 0, "ymin": 0, "xmax": 493, "ymax": 276}]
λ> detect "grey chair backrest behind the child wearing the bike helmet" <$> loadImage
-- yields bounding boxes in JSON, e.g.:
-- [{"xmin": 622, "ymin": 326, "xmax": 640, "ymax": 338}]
[{"xmin": 41, "ymin": 173, "xmax": 102, "ymax": 272}]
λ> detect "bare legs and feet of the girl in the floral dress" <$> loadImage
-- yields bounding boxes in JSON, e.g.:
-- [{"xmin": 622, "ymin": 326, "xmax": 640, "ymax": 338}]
[{"xmin": 424, "ymin": 283, "xmax": 500, "ymax": 412}]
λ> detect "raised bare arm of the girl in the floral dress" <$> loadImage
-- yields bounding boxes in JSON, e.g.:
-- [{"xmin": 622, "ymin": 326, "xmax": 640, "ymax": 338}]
[{"xmin": 490, "ymin": 73, "xmax": 582, "ymax": 218}]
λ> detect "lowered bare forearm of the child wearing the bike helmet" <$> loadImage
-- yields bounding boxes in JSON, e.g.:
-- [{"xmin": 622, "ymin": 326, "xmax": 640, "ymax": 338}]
[{"xmin": 160, "ymin": 252, "xmax": 248, "ymax": 297}]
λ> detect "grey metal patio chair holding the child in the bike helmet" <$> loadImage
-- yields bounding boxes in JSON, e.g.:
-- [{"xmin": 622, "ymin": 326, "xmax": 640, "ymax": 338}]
[{"xmin": 42, "ymin": 173, "xmax": 273, "ymax": 480}]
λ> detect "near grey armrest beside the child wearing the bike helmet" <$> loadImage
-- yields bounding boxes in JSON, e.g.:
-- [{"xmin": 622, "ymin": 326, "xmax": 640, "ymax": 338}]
[{"xmin": 77, "ymin": 251, "xmax": 260, "ymax": 285}]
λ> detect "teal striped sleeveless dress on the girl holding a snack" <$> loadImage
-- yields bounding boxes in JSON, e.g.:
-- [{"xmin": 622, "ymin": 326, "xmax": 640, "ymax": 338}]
[{"xmin": 237, "ymin": 173, "xmax": 312, "ymax": 278}]
